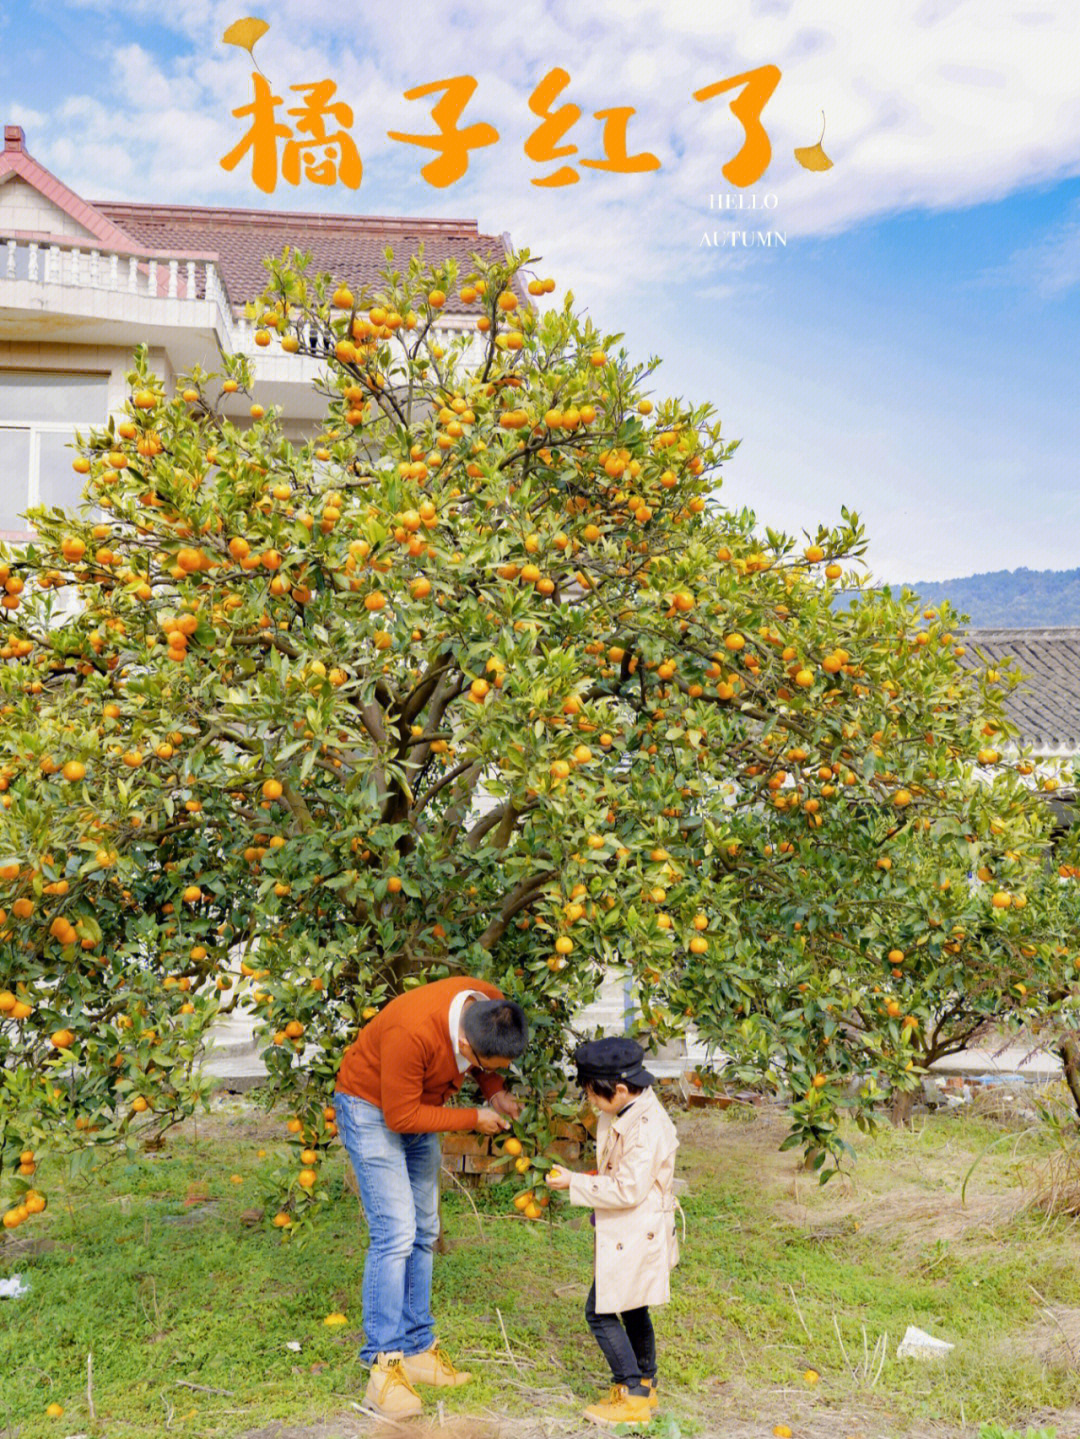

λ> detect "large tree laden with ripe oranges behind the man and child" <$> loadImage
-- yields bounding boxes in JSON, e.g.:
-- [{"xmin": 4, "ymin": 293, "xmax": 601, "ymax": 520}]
[{"xmin": 0, "ymin": 244, "xmax": 1067, "ymax": 1227}]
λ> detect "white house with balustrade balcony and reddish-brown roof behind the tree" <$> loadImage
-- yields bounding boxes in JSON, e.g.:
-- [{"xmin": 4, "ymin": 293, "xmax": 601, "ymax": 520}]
[{"xmin": 0, "ymin": 125, "xmax": 509, "ymax": 541}]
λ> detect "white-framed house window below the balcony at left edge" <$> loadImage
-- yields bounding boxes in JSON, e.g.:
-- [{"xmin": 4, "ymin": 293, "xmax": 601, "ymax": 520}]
[{"xmin": 0, "ymin": 370, "xmax": 108, "ymax": 540}]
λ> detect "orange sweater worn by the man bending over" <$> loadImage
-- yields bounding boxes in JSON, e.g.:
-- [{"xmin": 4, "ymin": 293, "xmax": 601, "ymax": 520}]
[{"xmin": 337, "ymin": 977, "xmax": 503, "ymax": 1134}]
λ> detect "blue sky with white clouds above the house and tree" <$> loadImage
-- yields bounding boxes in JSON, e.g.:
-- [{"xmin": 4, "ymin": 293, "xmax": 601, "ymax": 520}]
[{"xmin": 0, "ymin": 0, "xmax": 1080, "ymax": 581}]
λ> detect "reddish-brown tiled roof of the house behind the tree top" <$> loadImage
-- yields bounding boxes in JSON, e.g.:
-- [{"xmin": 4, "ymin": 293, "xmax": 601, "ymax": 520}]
[{"xmin": 93, "ymin": 200, "xmax": 523, "ymax": 314}]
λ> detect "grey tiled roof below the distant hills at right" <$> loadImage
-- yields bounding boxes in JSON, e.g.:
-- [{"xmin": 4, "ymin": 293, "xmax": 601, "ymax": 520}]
[{"xmin": 964, "ymin": 626, "xmax": 1080, "ymax": 754}]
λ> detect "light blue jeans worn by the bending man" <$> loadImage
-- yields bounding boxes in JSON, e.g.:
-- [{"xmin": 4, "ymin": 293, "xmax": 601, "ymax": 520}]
[{"xmin": 334, "ymin": 1091, "xmax": 441, "ymax": 1364}]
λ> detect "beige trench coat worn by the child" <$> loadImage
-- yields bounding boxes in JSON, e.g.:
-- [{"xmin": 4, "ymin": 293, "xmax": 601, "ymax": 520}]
[{"xmin": 568, "ymin": 1089, "xmax": 679, "ymax": 1314}]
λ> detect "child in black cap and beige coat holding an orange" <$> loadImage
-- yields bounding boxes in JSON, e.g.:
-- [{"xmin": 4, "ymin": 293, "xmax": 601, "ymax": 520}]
[{"xmin": 548, "ymin": 1039, "xmax": 679, "ymax": 1425}]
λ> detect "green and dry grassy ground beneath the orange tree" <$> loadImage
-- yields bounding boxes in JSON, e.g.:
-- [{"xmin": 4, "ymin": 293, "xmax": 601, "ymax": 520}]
[{"xmin": 0, "ymin": 1101, "xmax": 1080, "ymax": 1439}]
